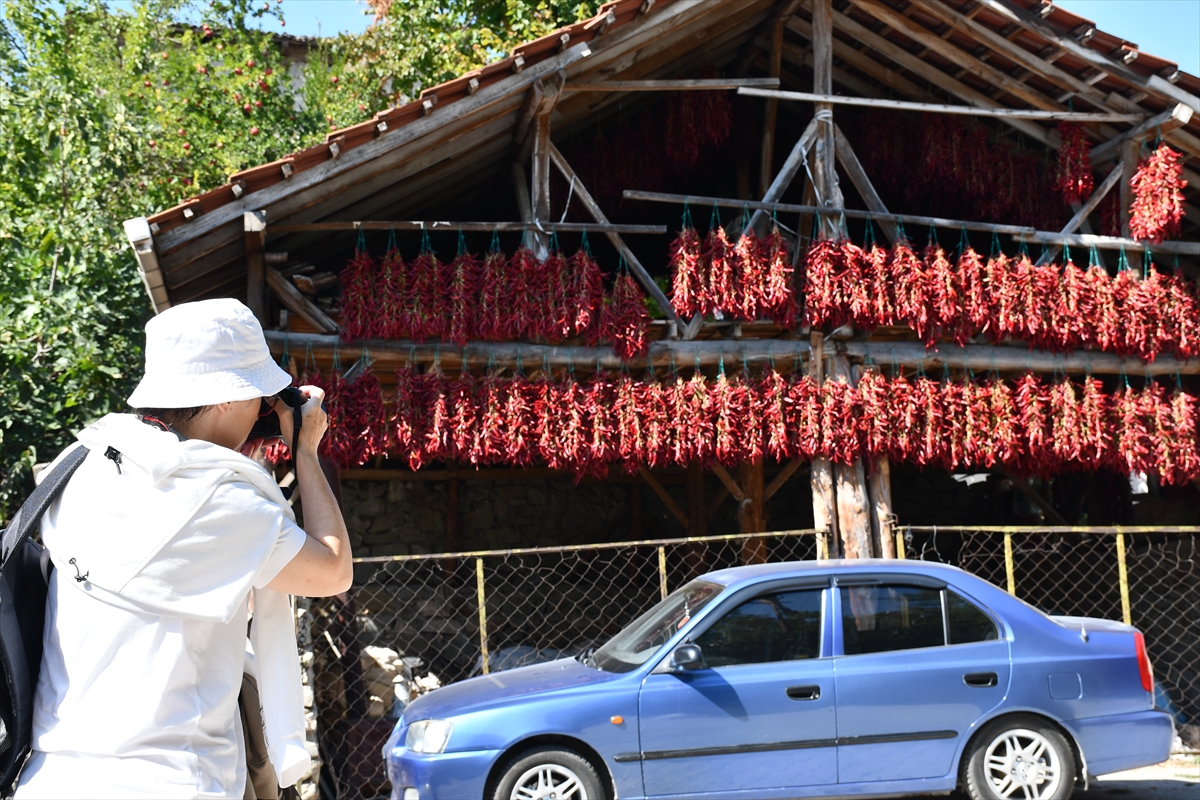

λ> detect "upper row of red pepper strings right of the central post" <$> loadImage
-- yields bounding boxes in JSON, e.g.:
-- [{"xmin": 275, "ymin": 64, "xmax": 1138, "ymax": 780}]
[{"xmin": 802, "ymin": 239, "xmax": 1200, "ymax": 361}]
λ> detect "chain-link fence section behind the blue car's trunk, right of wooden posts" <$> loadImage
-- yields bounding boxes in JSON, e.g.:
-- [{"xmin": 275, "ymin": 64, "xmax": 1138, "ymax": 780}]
[{"xmin": 900, "ymin": 527, "xmax": 1200, "ymax": 738}]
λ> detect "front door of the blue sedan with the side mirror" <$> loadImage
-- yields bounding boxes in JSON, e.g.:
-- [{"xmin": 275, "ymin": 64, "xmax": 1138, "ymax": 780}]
[{"xmin": 638, "ymin": 584, "xmax": 838, "ymax": 796}]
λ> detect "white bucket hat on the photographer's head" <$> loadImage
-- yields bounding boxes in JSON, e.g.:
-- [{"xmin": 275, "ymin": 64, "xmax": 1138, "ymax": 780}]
[{"xmin": 130, "ymin": 299, "xmax": 292, "ymax": 408}]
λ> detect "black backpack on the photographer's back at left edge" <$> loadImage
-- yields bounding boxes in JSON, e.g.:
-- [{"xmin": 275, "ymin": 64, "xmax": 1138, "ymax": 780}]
[{"xmin": 0, "ymin": 446, "xmax": 89, "ymax": 798}]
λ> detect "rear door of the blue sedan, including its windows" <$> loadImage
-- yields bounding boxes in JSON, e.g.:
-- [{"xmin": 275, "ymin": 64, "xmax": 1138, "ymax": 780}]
[{"xmin": 834, "ymin": 576, "xmax": 1010, "ymax": 783}]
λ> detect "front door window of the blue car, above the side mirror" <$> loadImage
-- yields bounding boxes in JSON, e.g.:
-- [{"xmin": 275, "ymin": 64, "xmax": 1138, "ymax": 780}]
[{"xmin": 696, "ymin": 589, "xmax": 821, "ymax": 667}]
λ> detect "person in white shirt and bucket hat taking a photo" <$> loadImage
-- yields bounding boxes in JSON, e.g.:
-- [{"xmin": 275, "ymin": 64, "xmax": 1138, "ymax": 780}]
[{"xmin": 16, "ymin": 300, "xmax": 352, "ymax": 800}]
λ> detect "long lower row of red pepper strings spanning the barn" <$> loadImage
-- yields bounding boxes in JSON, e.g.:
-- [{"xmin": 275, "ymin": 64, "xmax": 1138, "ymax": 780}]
[{"xmin": 307, "ymin": 365, "xmax": 1200, "ymax": 483}]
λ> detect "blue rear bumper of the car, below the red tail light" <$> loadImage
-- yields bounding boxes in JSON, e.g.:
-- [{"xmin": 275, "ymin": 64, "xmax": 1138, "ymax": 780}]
[{"xmin": 1066, "ymin": 709, "xmax": 1175, "ymax": 775}]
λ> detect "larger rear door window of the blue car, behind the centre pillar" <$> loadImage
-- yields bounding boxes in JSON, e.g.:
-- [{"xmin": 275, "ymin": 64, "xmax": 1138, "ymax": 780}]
[{"xmin": 839, "ymin": 584, "xmax": 946, "ymax": 656}]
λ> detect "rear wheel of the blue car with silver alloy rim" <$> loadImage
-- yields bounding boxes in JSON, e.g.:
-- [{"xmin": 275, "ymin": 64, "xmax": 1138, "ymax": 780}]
[{"xmin": 962, "ymin": 716, "xmax": 1075, "ymax": 800}]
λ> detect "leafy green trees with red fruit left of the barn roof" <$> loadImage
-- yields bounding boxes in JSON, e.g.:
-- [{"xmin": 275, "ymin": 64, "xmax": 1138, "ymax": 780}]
[{"xmin": 0, "ymin": 0, "xmax": 599, "ymax": 518}]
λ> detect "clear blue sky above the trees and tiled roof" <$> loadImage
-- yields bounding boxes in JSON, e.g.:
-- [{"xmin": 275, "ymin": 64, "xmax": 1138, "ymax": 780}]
[{"xmin": 255, "ymin": 0, "xmax": 1200, "ymax": 76}]
